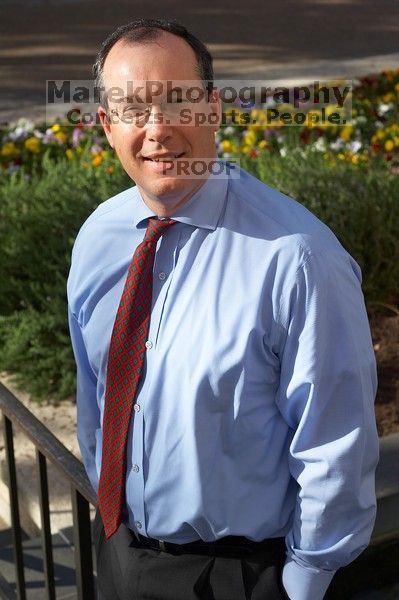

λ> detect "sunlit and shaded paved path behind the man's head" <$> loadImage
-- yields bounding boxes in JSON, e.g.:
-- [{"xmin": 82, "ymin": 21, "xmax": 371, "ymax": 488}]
[{"xmin": 0, "ymin": 0, "xmax": 399, "ymax": 122}]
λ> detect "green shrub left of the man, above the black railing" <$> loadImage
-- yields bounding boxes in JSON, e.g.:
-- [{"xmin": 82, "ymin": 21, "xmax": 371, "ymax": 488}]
[{"xmin": 0, "ymin": 154, "xmax": 131, "ymax": 398}]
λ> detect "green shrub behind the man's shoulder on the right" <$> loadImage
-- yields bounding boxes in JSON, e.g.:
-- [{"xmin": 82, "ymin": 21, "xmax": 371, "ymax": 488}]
[{"xmin": 242, "ymin": 149, "xmax": 399, "ymax": 303}]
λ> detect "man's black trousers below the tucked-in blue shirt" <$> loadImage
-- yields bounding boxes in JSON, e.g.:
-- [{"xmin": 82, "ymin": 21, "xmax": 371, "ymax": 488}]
[{"xmin": 93, "ymin": 511, "xmax": 289, "ymax": 600}]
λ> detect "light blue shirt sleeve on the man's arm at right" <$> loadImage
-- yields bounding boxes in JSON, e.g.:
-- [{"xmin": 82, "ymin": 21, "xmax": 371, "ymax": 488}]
[{"xmin": 277, "ymin": 251, "xmax": 379, "ymax": 600}]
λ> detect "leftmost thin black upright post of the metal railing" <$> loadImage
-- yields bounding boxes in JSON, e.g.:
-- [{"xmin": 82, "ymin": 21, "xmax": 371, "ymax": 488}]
[{"xmin": 3, "ymin": 415, "xmax": 26, "ymax": 600}]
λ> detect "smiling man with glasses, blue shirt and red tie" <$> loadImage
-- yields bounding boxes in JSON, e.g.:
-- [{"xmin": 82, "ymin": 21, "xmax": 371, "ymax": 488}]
[{"xmin": 68, "ymin": 20, "xmax": 378, "ymax": 600}]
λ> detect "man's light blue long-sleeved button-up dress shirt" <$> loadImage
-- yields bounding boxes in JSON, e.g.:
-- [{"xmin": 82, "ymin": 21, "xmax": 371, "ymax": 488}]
[{"xmin": 68, "ymin": 163, "xmax": 378, "ymax": 600}]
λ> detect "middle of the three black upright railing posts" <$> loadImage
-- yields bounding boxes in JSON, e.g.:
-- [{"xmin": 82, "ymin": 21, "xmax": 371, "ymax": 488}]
[{"xmin": 36, "ymin": 448, "xmax": 56, "ymax": 600}]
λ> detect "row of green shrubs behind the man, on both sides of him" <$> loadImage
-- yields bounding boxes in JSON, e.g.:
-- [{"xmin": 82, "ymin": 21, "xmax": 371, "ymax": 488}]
[{"xmin": 0, "ymin": 149, "xmax": 399, "ymax": 398}]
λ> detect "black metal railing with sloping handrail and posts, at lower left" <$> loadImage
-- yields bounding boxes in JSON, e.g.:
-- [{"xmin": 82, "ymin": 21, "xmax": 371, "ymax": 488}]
[{"xmin": 0, "ymin": 383, "xmax": 97, "ymax": 600}]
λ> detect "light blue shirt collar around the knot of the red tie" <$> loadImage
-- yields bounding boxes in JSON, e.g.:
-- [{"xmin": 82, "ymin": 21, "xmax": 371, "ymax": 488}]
[{"xmin": 133, "ymin": 161, "xmax": 228, "ymax": 230}]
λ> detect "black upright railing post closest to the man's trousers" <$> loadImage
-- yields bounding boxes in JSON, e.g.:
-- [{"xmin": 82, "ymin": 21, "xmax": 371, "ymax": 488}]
[{"xmin": 71, "ymin": 484, "xmax": 94, "ymax": 600}]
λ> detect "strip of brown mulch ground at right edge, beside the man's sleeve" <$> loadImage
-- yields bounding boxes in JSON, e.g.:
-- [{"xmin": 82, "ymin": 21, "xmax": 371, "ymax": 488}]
[{"xmin": 369, "ymin": 304, "xmax": 399, "ymax": 436}]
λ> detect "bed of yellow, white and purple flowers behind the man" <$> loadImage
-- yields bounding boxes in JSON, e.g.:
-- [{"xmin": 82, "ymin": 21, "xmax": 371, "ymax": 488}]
[{"xmin": 0, "ymin": 69, "xmax": 399, "ymax": 175}]
